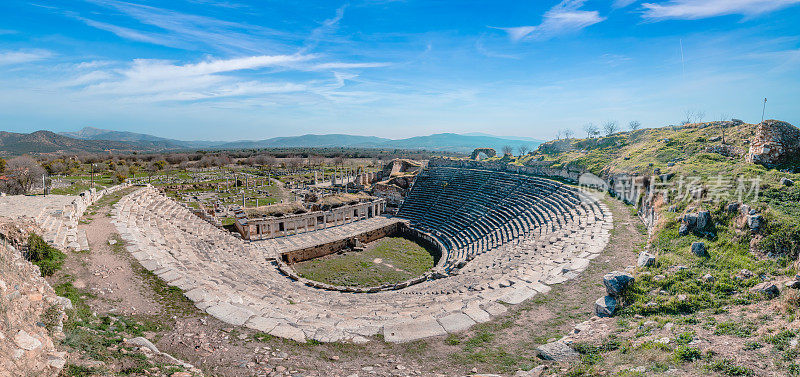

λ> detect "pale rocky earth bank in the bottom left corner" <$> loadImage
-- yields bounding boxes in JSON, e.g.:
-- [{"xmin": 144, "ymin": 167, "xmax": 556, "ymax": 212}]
[{"xmin": 0, "ymin": 241, "xmax": 71, "ymax": 377}]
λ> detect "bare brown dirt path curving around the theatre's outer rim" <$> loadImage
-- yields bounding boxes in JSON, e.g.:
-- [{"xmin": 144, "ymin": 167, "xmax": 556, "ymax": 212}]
[{"xmin": 53, "ymin": 191, "xmax": 645, "ymax": 377}]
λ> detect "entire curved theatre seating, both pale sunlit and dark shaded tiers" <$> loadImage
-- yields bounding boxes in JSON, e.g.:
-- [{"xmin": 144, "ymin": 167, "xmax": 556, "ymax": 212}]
[{"xmin": 113, "ymin": 167, "xmax": 613, "ymax": 342}]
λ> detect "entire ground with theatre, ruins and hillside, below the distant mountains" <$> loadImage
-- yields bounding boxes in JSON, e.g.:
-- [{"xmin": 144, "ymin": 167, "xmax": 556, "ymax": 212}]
[{"xmin": 0, "ymin": 120, "xmax": 800, "ymax": 377}]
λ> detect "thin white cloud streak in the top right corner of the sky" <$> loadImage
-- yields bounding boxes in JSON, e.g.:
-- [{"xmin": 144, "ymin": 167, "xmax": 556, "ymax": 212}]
[{"xmin": 642, "ymin": 0, "xmax": 800, "ymax": 21}]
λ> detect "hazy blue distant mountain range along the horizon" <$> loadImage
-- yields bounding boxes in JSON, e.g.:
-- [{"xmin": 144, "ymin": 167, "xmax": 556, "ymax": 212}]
[{"xmin": 0, "ymin": 127, "xmax": 542, "ymax": 155}]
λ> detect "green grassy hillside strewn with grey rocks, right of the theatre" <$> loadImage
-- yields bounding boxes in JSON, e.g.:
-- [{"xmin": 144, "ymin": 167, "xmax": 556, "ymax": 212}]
[{"xmin": 494, "ymin": 122, "xmax": 800, "ymax": 376}]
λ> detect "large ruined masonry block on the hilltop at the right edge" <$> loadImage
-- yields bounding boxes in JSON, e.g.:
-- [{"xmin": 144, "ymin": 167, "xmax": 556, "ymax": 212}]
[{"xmin": 745, "ymin": 119, "xmax": 800, "ymax": 166}]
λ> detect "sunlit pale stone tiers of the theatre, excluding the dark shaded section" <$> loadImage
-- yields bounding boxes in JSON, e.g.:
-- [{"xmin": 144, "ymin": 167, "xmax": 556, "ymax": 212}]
[{"xmin": 112, "ymin": 168, "xmax": 613, "ymax": 343}]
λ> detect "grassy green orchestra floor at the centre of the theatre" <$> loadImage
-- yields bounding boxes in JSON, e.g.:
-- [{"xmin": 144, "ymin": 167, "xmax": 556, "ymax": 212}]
[{"xmin": 293, "ymin": 237, "xmax": 433, "ymax": 287}]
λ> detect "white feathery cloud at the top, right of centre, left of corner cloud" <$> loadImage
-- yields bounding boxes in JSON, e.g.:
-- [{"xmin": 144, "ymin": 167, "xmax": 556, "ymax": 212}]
[{"xmin": 490, "ymin": 0, "xmax": 605, "ymax": 42}]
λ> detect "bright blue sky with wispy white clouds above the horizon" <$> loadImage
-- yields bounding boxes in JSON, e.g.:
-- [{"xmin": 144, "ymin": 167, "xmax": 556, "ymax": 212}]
[{"xmin": 0, "ymin": 0, "xmax": 800, "ymax": 140}]
